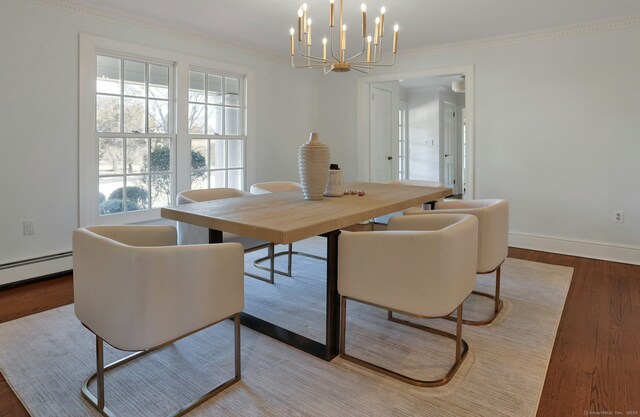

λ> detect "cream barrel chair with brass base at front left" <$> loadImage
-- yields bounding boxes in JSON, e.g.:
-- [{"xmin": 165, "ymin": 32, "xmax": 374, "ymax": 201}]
[{"xmin": 73, "ymin": 226, "xmax": 244, "ymax": 416}]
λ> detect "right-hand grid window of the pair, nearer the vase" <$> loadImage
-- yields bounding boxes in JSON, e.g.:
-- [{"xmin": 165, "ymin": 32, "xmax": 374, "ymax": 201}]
[{"xmin": 188, "ymin": 70, "xmax": 246, "ymax": 189}]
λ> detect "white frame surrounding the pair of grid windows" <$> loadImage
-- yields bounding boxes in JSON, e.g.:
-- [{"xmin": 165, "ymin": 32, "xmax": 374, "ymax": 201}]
[{"xmin": 78, "ymin": 33, "xmax": 256, "ymax": 226}]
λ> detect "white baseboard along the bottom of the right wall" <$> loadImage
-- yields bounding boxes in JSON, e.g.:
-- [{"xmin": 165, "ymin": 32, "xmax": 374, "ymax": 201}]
[{"xmin": 509, "ymin": 232, "xmax": 640, "ymax": 265}]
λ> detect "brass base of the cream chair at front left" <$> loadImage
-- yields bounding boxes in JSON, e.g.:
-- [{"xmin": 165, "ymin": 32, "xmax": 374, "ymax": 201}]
[{"xmin": 82, "ymin": 313, "xmax": 242, "ymax": 417}]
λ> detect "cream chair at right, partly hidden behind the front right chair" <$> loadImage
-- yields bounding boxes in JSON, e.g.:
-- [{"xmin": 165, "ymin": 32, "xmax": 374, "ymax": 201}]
[{"xmin": 405, "ymin": 199, "xmax": 509, "ymax": 325}]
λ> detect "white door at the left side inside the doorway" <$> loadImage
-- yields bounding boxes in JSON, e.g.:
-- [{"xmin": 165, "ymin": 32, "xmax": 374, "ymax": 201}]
[{"xmin": 369, "ymin": 87, "xmax": 397, "ymax": 182}]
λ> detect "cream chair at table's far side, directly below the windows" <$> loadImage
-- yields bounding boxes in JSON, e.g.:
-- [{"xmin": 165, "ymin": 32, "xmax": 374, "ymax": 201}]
[{"xmin": 176, "ymin": 188, "xmax": 277, "ymax": 284}]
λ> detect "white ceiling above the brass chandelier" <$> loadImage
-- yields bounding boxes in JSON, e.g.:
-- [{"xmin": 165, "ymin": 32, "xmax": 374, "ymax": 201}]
[{"xmin": 63, "ymin": 0, "xmax": 640, "ymax": 57}]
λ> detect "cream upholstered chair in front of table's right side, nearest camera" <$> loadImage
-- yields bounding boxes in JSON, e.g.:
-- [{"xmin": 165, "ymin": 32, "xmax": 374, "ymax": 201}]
[{"xmin": 338, "ymin": 214, "xmax": 478, "ymax": 386}]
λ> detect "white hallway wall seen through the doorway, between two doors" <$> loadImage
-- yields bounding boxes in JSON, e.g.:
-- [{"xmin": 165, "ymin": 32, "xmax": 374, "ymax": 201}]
[{"xmin": 407, "ymin": 88, "xmax": 440, "ymax": 181}]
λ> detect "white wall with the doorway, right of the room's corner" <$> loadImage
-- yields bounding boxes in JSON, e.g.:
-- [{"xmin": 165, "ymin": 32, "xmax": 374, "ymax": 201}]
[{"xmin": 318, "ymin": 21, "xmax": 640, "ymax": 263}]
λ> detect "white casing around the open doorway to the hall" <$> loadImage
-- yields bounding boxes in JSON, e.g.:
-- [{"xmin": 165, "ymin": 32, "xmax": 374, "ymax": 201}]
[{"xmin": 357, "ymin": 64, "xmax": 475, "ymax": 199}]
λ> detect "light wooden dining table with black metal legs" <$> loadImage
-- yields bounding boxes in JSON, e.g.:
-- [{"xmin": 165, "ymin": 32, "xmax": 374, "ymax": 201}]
[{"xmin": 161, "ymin": 182, "xmax": 452, "ymax": 361}]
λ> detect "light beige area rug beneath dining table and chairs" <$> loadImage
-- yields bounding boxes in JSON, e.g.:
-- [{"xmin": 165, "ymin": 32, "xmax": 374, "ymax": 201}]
[{"xmin": 0, "ymin": 238, "xmax": 572, "ymax": 417}]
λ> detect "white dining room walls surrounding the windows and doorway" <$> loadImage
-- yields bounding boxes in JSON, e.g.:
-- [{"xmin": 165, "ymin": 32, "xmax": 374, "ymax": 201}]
[{"xmin": 0, "ymin": 0, "xmax": 640, "ymax": 284}]
